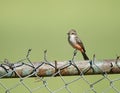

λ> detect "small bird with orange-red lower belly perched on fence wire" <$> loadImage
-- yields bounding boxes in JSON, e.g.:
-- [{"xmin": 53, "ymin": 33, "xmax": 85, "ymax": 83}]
[{"xmin": 67, "ymin": 29, "xmax": 89, "ymax": 60}]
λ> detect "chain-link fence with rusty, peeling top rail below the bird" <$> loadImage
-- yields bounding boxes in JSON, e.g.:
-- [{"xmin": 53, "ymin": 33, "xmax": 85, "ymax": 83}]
[{"xmin": 0, "ymin": 49, "xmax": 120, "ymax": 93}]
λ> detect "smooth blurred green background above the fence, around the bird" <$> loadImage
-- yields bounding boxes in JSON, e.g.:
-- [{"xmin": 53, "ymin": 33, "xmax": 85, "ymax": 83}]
[{"xmin": 0, "ymin": 0, "xmax": 120, "ymax": 93}]
